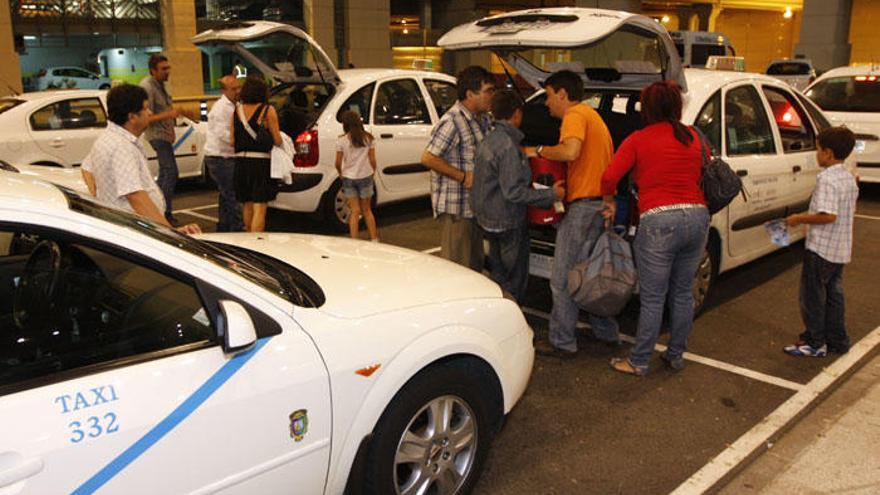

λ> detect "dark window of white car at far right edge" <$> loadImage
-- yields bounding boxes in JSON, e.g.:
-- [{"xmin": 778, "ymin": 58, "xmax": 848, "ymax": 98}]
[{"xmin": 807, "ymin": 76, "xmax": 880, "ymax": 112}]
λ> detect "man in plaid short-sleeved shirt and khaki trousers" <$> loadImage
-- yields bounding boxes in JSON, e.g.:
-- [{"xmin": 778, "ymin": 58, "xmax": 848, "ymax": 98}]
[{"xmin": 422, "ymin": 66, "xmax": 495, "ymax": 271}]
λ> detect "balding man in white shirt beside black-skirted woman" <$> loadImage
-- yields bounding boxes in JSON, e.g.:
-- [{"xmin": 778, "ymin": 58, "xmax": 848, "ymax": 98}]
[{"xmin": 205, "ymin": 75, "xmax": 244, "ymax": 232}]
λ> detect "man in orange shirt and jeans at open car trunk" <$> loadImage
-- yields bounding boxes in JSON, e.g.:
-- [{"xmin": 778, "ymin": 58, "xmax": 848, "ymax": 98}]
[{"xmin": 525, "ymin": 70, "xmax": 620, "ymax": 358}]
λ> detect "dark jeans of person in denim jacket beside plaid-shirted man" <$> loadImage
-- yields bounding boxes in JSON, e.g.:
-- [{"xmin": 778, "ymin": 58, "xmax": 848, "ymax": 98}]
[{"xmin": 484, "ymin": 226, "xmax": 529, "ymax": 304}]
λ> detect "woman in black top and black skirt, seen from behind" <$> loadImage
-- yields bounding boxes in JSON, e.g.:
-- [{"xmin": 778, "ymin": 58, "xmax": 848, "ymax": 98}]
[{"xmin": 232, "ymin": 75, "xmax": 281, "ymax": 232}]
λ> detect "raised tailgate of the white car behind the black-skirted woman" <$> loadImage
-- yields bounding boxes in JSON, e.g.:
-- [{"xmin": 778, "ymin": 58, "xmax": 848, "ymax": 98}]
[{"xmin": 192, "ymin": 21, "xmax": 339, "ymax": 83}]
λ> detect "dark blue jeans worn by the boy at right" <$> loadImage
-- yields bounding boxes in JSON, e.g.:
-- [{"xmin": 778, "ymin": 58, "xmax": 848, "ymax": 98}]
[{"xmin": 800, "ymin": 250, "xmax": 850, "ymax": 352}]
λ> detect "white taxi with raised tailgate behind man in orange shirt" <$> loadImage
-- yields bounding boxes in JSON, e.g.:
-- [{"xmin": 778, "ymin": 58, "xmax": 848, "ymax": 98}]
[{"xmin": 438, "ymin": 8, "xmax": 852, "ymax": 309}]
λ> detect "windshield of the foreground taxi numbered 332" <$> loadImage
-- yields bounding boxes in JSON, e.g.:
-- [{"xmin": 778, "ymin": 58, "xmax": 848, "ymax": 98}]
[{"xmin": 58, "ymin": 186, "xmax": 324, "ymax": 307}]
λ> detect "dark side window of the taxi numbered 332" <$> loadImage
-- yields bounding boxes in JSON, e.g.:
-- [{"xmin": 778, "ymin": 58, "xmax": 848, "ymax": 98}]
[{"xmin": 0, "ymin": 227, "xmax": 215, "ymax": 394}]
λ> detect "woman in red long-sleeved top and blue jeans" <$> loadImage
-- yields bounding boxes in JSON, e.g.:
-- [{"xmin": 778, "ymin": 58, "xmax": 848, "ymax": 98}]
[{"xmin": 602, "ymin": 81, "xmax": 709, "ymax": 376}]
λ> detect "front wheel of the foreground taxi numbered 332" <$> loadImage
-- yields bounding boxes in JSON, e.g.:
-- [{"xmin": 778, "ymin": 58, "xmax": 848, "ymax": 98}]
[{"xmin": 362, "ymin": 360, "xmax": 500, "ymax": 495}]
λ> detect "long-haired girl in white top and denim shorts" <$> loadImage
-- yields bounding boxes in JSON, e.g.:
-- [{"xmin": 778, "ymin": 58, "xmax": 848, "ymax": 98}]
[{"xmin": 336, "ymin": 112, "xmax": 379, "ymax": 242}]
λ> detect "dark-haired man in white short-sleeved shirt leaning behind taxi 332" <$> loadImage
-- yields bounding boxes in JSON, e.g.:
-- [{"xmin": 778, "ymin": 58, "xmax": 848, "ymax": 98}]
[{"xmin": 81, "ymin": 84, "xmax": 201, "ymax": 234}]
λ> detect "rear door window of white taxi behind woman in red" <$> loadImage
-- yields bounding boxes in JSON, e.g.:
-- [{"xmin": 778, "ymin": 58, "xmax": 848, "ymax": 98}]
[{"xmin": 724, "ymin": 85, "xmax": 776, "ymax": 156}]
